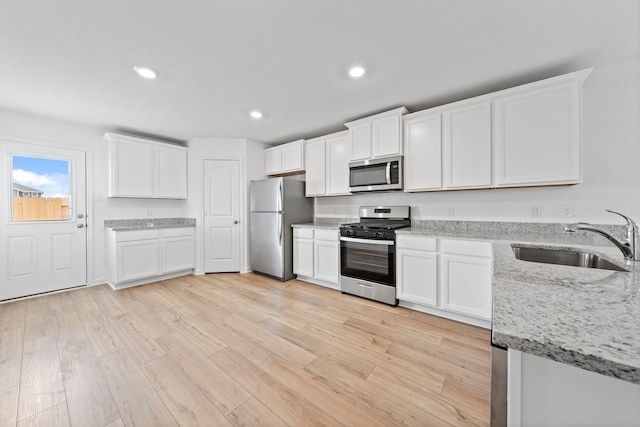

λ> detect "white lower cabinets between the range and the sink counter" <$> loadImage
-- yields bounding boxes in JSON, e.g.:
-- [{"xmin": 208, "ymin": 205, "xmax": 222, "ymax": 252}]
[{"xmin": 396, "ymin": 234, "xmax": 493, "ymax": 327}]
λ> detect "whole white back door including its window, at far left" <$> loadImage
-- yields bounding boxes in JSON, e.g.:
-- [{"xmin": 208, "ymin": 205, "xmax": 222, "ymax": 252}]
[{"xmin": 0, "ymin": 140, "xmax": 87, "ymax": 300}]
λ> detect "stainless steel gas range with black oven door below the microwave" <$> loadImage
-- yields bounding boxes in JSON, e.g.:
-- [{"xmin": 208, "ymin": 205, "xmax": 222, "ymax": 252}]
[{"xmin": 340, "ymin": 206, "xmax": 411, "ymax": 306}]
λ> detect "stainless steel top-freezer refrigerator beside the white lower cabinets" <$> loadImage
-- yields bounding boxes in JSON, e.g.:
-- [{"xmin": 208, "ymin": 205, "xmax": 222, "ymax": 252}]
[{"xmin": 250, "ymin": 177, "xmax": 313, "ymax": 281}]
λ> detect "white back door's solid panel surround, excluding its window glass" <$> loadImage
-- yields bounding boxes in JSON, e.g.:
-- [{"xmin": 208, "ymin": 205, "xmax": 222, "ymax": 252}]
[{"xmin": 0, "ymin": 140, "xmax": 87, "ymax": 300}]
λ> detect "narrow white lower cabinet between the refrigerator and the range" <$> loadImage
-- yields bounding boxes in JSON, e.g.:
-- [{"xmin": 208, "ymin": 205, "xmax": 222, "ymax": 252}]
[{"xmin": 293, "ymin": 227, "xmax": 340, "ymax": 289}]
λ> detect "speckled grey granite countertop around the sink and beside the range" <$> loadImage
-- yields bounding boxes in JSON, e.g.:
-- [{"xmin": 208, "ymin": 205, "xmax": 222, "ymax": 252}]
[{"xmin": 296, "ymin": 221, "xmax": 640, "ymax": 384}]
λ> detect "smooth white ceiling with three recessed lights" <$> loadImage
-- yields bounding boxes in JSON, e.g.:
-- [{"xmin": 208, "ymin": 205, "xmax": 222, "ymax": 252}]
[{"xmin": 0, "ymin": 0, "xmax": 640, "ymax": 143}]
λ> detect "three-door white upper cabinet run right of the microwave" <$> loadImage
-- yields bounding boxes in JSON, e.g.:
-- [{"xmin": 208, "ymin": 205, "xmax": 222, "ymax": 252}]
[{"xmin": 403, "ymin": 69, "xmax": 591, "ymax": 191}]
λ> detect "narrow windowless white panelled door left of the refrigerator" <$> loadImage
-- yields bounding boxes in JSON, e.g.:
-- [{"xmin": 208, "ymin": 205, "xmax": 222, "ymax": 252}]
[{"xmin": 203, "ymin": 160, "xmax": 240, "ymax": 273}]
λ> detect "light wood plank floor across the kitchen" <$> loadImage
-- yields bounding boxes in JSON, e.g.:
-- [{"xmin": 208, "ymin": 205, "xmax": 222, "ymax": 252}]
[{"xmin": 0, "ymin": 274, "xmax": 490, "ymax": 427}]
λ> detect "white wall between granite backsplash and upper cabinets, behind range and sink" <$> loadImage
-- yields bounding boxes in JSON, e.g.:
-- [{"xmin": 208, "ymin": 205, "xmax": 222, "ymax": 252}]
[{"xmin": 316, "ymin": 58, "xmax": 640, "ymax": 224}]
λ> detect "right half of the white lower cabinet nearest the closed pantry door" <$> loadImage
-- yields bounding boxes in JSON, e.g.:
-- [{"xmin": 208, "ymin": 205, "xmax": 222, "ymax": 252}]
[{"xmin": 160, "ymin": 228, "xmax": 196, "ymax": 274}]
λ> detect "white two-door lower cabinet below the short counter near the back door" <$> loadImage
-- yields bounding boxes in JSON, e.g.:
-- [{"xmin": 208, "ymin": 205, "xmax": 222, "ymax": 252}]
[{"xmin": 109, "ymin": 227, "xmax": 195, "ymax": 289}]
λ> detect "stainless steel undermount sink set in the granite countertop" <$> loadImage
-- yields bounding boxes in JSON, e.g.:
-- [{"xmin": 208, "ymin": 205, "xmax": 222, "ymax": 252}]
[{"xmin": 511, "ymin": 245, "xmax": 627, "ymax": 271}]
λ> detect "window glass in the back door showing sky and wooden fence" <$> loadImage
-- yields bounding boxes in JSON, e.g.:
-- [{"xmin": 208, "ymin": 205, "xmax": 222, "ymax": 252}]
[{"xmin": 11, "ymin": 156, "xmax": 73, "ymax": 222}]
